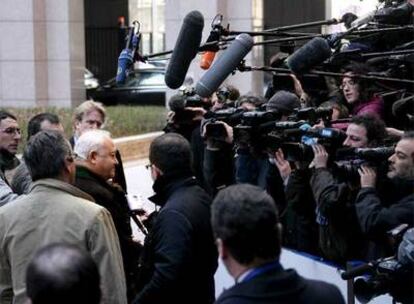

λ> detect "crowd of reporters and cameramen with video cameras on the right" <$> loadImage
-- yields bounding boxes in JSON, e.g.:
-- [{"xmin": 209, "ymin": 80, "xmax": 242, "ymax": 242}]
[{"xmin": 165, "ymin": 0, "xmax": 414, "ymax": 270}]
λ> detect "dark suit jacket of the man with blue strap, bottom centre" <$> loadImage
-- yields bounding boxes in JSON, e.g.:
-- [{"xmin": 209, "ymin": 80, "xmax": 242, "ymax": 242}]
[{"xmin": 215, "ymin": 269, "xmax": 345, "ymax": 304}]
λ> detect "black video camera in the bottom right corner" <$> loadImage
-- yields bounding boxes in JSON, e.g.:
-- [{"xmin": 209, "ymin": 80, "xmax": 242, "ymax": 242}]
[{"xmin": 341, "ymin": 224, "xmax": 414, "ymax": 304}]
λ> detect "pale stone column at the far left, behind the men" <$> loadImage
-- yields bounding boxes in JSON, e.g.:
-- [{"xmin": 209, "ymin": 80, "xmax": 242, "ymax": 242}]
[{"xmin": 0, "ymin": 0, "xmax": 85, "ymax": 107}]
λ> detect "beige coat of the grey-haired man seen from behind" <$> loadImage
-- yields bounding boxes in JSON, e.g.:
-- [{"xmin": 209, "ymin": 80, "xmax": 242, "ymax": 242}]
[{"xmin": 0, "ymin": 179, "xmax": 127, "ymax": 304}]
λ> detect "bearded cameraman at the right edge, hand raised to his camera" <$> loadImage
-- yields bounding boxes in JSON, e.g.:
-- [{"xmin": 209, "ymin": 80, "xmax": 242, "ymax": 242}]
[{"xmin": 355, "ymin": 131, "xmax": 414, "ymax": 254}]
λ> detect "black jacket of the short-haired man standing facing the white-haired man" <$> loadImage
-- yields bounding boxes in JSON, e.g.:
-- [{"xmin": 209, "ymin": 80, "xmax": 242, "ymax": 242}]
[{"xmin": 134, "ymin": 175, "xmax": 217, "ymax": 304}]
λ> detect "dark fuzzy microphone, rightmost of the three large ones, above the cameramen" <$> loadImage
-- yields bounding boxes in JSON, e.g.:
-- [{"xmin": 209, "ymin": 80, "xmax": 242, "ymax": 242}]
[{"xmin": 286, "ymin": 37, "xmax": 332, "ymax": 74}]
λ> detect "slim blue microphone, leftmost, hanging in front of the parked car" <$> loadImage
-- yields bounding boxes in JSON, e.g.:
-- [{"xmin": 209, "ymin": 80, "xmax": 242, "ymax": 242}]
[{"xmin": 115, "ymin": 22, "xmax": 141, "ymax": 84}]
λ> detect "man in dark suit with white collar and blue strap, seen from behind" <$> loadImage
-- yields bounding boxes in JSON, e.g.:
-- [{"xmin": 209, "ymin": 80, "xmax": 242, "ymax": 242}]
[{"xmin": 212, "ymin": 184, "xmax": 345, "ymax": 304}]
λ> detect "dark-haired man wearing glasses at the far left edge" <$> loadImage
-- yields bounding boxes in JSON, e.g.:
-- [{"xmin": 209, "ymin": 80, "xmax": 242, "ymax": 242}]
[{"xmin": 0, "ymin": 111, "xmax": 22, "ymax": 184}]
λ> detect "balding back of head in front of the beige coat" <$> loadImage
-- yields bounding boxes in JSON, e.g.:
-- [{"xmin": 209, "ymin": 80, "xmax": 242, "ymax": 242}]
[{"xmin": 26, "ymin": 243, "xmax": 101, "ymax": 304}]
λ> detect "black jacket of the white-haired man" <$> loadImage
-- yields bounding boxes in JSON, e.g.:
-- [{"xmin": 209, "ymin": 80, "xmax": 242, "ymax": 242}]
[{"xmin": 75, "ymin": 166, "xmax": 142, "ymax": 298}]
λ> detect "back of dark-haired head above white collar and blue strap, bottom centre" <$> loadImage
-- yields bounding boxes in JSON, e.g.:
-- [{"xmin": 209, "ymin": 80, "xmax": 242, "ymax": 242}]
[{"xmin": 212, "ymin": 184, "xmax": 281, "ymax": 265}]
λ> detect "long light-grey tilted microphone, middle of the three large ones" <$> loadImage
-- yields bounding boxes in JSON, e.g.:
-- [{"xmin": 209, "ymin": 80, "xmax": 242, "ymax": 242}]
[{"xmin": 196, "ymin": 34, "xmax": 253, "ymax": 97}]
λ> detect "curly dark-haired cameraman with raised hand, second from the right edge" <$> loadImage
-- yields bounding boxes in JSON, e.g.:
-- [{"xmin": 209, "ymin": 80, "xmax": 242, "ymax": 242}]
[{"xmin": 311, "ymin": 116, "xmax": 386, "ymax": 262}]
